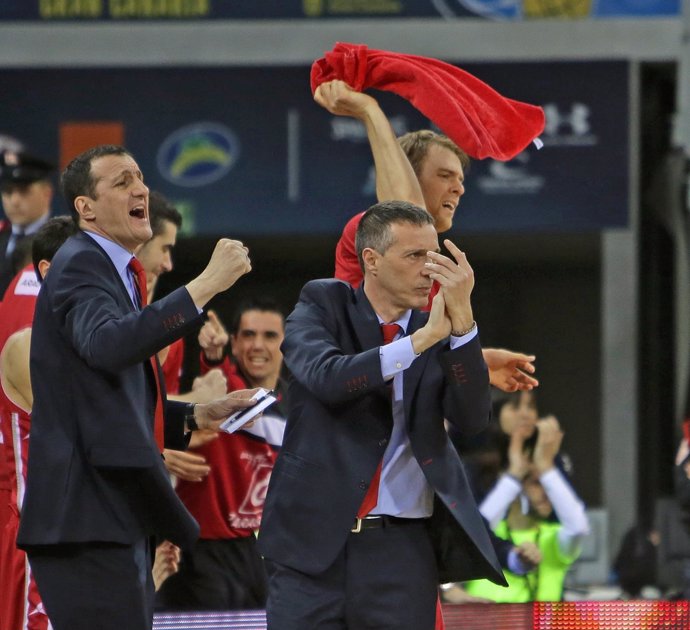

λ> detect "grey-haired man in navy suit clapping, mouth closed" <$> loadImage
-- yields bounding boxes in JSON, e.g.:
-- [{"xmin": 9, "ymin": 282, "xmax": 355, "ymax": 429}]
[{"xmin": 259, "ymin": 201, "xmax": 505, "ymax": 630}]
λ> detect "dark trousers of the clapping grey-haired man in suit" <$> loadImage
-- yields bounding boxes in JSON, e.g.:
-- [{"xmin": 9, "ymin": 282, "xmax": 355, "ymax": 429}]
[{"xmin": 266, "ymin": 521, "xmax": 438, "ymax": 630}]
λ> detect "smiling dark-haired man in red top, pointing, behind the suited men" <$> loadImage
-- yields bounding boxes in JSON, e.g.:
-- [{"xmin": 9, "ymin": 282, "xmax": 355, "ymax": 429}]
[{"xmin": 158, "ymin": 298, "xmax": 285, "ymax": 610}]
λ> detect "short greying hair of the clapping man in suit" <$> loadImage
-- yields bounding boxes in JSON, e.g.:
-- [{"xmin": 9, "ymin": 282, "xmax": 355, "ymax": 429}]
[{"xmin": 355, "ymin": 201, "xmax": 434, "ymax": 271}]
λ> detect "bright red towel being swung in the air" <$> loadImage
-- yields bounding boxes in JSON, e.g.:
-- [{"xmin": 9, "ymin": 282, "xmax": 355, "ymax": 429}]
[{"xmin": 311, "ymin": 43, "xmax": 544, "ymax": 161}]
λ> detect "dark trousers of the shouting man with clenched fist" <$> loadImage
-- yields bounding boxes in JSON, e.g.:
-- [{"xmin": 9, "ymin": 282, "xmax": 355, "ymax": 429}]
[{"xmin": 27, "ymin": 539, "xmax": 154, "ymax": 630}]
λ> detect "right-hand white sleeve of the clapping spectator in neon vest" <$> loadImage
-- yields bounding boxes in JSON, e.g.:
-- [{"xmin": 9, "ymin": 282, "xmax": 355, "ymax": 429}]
[{"xmin": 539, "ymin": 468, "xmax": 589, "ymax": 555}]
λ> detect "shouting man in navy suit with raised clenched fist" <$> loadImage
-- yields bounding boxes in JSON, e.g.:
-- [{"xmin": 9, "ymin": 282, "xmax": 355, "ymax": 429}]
[{"xmin": 18, "ymin": 145, "xmax": 253, "ymax": 630}]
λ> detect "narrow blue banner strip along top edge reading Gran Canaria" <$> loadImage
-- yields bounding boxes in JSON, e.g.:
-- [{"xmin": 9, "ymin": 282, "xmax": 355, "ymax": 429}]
[{"xmin": 0, "ymin": 0, "xmax": 681, "ymax": 21}]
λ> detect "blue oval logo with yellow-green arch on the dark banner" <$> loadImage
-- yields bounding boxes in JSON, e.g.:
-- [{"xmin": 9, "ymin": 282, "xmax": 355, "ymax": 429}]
[{"xmin": 157, "ymin": 122, "xmax": 240, "ymax": 188}]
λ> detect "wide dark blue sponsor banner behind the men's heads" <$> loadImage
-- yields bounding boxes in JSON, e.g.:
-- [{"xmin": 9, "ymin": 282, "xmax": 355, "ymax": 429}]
[{"xmin": 0, "ymin": 62, "xmax": 629, "ymax": 234}]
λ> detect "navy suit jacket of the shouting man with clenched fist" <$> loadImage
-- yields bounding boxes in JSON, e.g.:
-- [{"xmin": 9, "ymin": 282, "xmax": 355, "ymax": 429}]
[{"xmin": 17, "ymin": 233, "xmax": 199, "ymax": 548}]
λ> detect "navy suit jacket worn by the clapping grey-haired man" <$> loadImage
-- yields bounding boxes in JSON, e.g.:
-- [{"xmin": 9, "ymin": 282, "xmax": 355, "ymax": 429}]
[{"xmin": 259, "ymin": 280, "xmax": 505, "ymax": 584}]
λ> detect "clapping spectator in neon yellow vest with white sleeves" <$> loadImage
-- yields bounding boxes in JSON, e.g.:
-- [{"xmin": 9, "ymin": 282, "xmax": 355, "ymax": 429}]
[{"xmin": 466, "ymin": 416, "xmax": 589, "ymax": 603}]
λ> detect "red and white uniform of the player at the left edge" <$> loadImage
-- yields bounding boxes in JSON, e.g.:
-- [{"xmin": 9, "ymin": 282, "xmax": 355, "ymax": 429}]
[{"xmin": 0, "ymin": 265, "xmax": 52, "ymax": 630}]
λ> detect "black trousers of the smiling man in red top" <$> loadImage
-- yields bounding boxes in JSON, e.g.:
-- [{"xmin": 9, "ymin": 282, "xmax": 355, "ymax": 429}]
[{"xmin": 156, "ymin": 535, "xmax": 266, "ymax": 610}]
